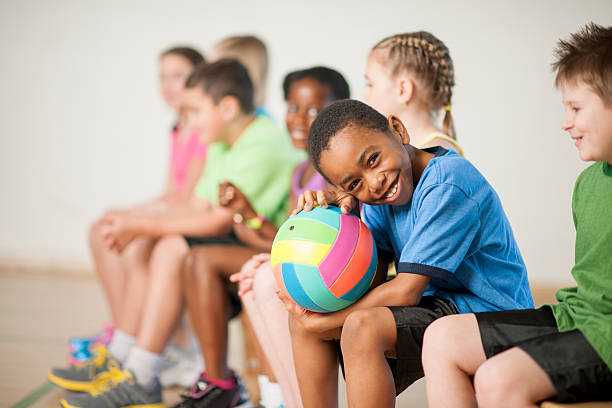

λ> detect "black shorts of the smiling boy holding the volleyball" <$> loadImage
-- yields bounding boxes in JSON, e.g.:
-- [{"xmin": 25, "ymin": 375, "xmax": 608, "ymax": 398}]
[{"xmin": 337, "ymin": 296, "xmax": 458, "ymax": 395}]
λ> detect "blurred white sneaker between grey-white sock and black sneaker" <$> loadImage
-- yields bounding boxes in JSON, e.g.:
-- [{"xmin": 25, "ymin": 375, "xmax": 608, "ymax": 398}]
[{"xmin": 159, "ymin": 342, "xmax": 204, "ymax": 388}]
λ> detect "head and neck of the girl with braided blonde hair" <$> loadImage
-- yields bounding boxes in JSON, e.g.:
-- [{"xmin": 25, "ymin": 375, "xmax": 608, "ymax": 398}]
[{"xmin": 363, "ymin": 31, "xmax": 463, "ymax": 155}]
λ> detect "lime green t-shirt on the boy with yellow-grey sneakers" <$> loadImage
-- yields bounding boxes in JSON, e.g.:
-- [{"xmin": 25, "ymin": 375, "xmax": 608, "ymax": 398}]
[{"xmin": 195, "ymin": 116, "xmax": 305, "ymax": 226}]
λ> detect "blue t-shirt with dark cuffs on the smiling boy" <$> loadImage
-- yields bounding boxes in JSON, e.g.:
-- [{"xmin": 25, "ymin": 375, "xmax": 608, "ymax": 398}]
[{"xmin": 363, "ymin": 147, "xmax": 533, "ymax": 313}]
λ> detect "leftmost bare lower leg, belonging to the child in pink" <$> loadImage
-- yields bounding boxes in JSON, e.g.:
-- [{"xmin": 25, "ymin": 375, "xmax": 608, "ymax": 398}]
[{"xmin": 89, "ymin": 221, "xmax": 127, "ymax": 324}]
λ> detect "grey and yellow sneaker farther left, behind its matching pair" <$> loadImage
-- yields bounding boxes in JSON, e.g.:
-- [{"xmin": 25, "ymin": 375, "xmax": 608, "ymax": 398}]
[{"xmin": 48, "ymin": 346, "xmax": 119, "ymax": 391}]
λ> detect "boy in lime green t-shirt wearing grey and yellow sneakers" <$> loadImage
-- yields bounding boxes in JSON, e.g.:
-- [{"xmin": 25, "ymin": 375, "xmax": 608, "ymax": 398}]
[{"xmin": 54, "ymin": 59, "xmax": 303, "ymax": 408}]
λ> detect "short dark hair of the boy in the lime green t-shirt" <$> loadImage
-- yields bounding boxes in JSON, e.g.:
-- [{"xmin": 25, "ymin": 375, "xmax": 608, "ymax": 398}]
[{"xmin": 185, "ymin": 58, "xmax": 254, "ymax": 113}]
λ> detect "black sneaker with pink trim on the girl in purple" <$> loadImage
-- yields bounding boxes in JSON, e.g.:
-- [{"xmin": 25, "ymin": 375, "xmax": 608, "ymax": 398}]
[{"xmin": 174, "ymin": 371, "xmax": 252, "ymax": 408}]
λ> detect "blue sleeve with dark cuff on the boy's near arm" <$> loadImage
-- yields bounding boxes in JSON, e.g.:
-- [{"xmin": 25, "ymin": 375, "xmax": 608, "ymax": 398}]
[{"xmin": 397, "ymin": 184, "xmax": 480, "ymax": 281}]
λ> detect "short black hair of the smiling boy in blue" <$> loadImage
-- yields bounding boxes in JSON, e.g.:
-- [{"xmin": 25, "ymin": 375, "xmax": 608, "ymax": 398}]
[{"xmin": 308, "ymin": 99, "xmax": 389, "ymax": 180}]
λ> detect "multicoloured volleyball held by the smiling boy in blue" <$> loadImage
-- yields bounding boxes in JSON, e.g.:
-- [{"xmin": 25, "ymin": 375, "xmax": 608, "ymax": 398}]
[{"xmin": 272, "ymin": 206, "xmax": 378, "ymax": 312}]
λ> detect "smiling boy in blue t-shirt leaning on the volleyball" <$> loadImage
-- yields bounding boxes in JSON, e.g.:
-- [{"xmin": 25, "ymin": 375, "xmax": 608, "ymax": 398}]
[{"xmin": 280, "ymin": 100, "xmax": 533, "ymax": 407}]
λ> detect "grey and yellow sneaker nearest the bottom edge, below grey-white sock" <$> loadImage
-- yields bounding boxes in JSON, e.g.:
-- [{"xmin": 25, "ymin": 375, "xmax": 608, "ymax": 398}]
[{"xmin": 60, "ymin": 364, "xmax": 164, "ymax": 408}]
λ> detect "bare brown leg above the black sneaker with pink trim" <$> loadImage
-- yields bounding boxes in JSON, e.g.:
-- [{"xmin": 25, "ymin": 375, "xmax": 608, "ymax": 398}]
[{"xmin": 183, "ymin": 245, "xmax": 257, "ymax": 379}]
